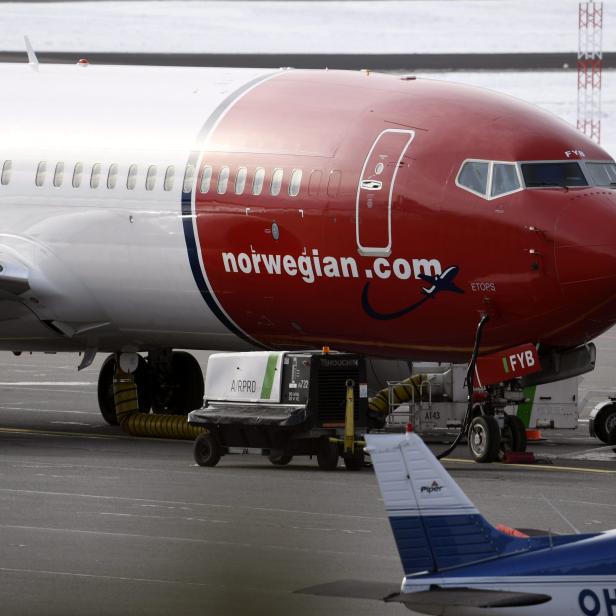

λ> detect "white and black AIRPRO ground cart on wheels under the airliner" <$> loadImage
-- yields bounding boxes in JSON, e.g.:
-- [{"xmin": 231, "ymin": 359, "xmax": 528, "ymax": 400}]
[{"xmin": 188, "ymin": 351, "xmax": 369, "ymax": 470}]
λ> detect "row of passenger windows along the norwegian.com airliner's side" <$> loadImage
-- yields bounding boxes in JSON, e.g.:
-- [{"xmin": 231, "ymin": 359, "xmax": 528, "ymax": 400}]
[{"xmin": 0, "ymin": 160, "xmax": 306, "ymax": 197}]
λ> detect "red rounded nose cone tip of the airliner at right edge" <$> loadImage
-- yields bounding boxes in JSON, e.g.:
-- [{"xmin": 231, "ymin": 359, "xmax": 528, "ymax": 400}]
[{"xmin": 555, "ymin": 191, "xmax": 616, "ymax": 308}]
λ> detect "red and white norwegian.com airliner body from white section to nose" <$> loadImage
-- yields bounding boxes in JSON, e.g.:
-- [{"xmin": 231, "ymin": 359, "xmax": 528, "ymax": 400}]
[{"xmin": 0, "ymin": 51, "xmax": 616, "ymax": 424}]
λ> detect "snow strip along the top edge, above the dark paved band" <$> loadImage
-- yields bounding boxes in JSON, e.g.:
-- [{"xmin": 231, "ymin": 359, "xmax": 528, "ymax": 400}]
[{"xmin": 0, "ymin": 0, "xmax": 616, "ymax": 53}]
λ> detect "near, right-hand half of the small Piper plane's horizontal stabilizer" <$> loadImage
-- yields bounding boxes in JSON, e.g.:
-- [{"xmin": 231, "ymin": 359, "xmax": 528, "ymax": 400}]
[{"xmin": 392, "ymin": 587, "xmax": 552, "ymax": 612}]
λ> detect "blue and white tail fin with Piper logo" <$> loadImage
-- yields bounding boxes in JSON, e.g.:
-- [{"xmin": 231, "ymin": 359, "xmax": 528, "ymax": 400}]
[{"xmin": 366, "ymin": 432, "xmax": 530, "ymax": 575}]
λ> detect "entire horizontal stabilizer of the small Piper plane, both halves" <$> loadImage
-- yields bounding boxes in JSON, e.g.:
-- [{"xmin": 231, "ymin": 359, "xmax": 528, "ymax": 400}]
[{"xmin": 296, "ymin": 580, "xmax": 552, "ymax": 612}]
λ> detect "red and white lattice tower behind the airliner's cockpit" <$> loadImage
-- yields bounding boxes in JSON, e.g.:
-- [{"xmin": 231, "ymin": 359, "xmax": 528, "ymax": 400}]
[{"xmin": 577, "ymin": 0, "xmax": 603, "ymax": 143}]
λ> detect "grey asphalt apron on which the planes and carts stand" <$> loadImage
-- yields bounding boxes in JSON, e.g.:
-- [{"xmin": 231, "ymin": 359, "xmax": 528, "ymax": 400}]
[{"xmin": 0, "ymin": 346, "xmax": 616, "ymax": 616}]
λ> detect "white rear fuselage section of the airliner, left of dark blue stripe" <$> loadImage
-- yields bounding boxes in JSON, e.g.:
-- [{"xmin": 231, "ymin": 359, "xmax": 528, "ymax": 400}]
[{"xmin": 0, "ymin": 64, "xmax": 271, "ymax": 350}]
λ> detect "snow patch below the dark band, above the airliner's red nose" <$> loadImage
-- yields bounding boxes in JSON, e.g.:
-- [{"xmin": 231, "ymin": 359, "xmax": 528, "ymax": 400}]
[{"xmin": 416, "ymin": 70, "xmax": 616, "ymax": 157}]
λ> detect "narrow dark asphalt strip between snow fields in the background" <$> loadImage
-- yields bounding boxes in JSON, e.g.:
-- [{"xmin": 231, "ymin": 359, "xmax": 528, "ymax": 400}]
[{"xmin": 0, "ymin": 50, "xmax": 616, "ymax": 71}]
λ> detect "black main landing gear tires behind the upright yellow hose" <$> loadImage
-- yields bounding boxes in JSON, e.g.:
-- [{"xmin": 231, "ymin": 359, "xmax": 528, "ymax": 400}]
[{"xmin": 98, "ymin": 351, "xmax": 203, "ymax": 425}]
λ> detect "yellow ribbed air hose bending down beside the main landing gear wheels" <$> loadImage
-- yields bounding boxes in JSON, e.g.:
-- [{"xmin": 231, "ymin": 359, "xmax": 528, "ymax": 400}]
[{"xmin": 113, "ymin": 363, "xmax": 206, "ymax": 441}]
